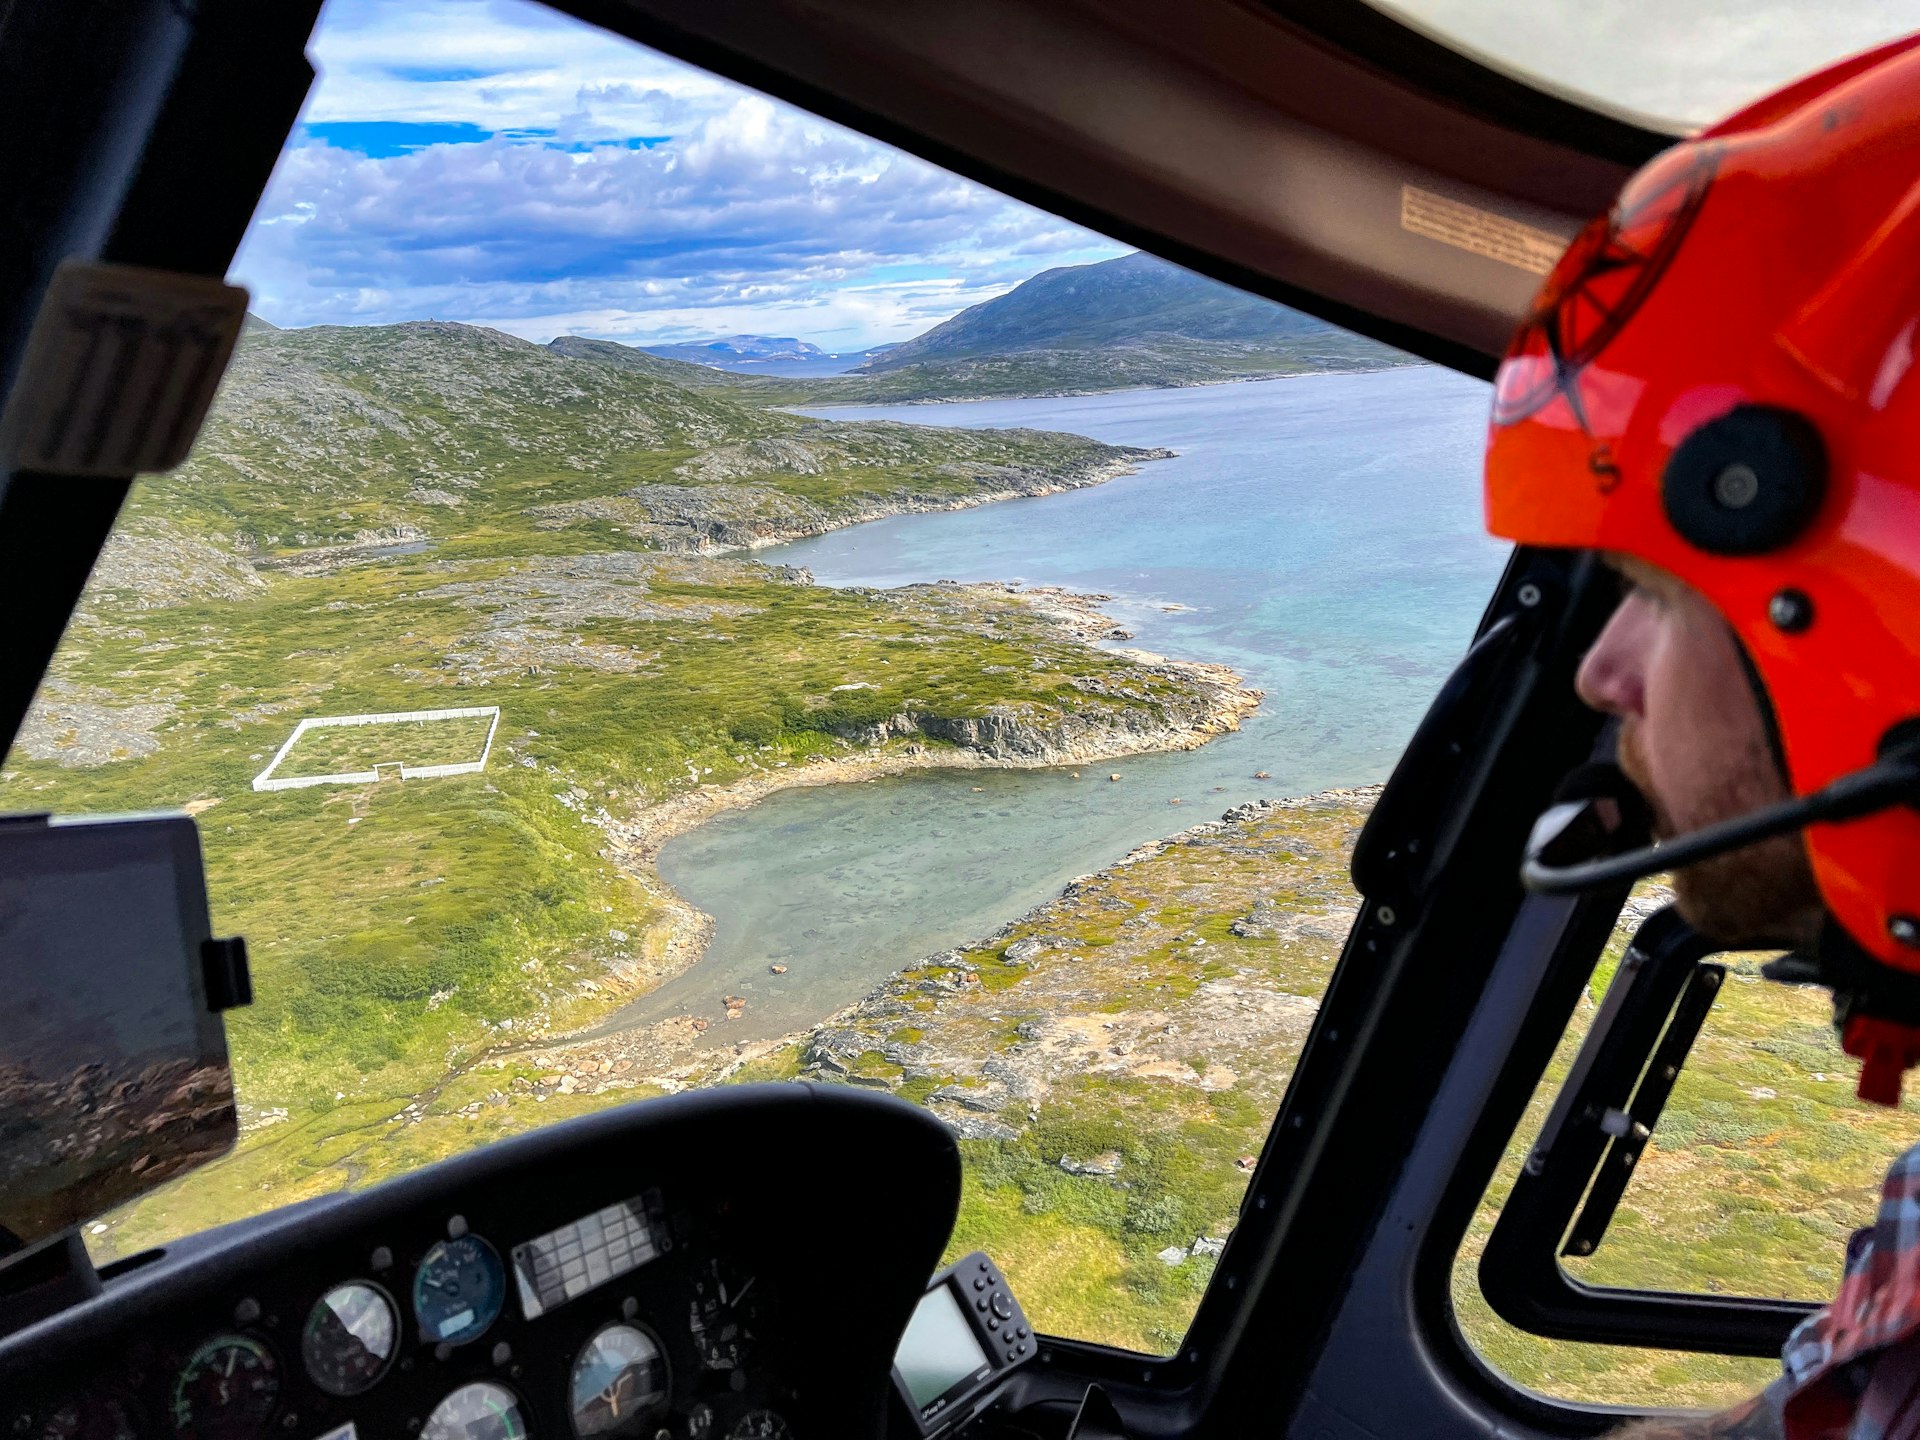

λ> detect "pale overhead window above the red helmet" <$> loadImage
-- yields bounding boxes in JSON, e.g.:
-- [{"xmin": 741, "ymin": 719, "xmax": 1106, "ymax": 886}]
[{"xmin": 1369, "ymin": 0, "xmax": 1920, "ymax": 131}]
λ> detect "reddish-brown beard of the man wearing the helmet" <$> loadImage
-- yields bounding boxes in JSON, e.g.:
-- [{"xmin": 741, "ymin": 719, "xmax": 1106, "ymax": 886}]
[{"xmin": 1619, "ymin": 726, "xmax": 1822, "ymax": 948}]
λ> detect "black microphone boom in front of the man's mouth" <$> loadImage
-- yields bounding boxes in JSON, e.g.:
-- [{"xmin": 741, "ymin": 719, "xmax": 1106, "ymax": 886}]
[{"xmin": 1521, "ymin": 745, "xmax": 1920, "ymax": 895}]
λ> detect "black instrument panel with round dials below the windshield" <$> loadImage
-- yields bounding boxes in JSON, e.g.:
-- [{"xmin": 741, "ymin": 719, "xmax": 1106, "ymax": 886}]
[{"xmin": 0, "ymin": 1085, "xmax": 958, "ymax": 1440}]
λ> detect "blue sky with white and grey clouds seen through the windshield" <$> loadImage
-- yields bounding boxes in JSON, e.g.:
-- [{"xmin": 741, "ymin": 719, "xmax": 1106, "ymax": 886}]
[{"xmin": 234, "ymin": 0, "xmax": 1127, "ymax": 349}]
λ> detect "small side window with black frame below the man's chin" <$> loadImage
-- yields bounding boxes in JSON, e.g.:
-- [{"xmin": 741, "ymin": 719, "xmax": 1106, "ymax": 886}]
[{"xmin": 1453, "ymin": 887, "xmax": 1912, "ymax": 1407}]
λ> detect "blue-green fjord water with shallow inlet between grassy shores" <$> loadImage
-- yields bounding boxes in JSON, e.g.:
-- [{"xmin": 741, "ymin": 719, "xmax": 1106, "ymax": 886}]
[{"xmin": 614, "ymin": 367, "xmax": 1505, "ymax": 1043}]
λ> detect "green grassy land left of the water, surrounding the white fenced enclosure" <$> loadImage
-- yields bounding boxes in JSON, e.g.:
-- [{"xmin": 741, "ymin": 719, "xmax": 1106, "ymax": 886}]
[{"xmin": 0, "ymin": 324, "xmax": 1228, "ymax": 1254}]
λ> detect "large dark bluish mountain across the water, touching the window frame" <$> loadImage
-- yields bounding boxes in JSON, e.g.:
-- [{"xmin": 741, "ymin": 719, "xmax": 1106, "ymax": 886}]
[{"xmin": 860, "ymin": 252, "xmax": 1342, "ymax": 374}]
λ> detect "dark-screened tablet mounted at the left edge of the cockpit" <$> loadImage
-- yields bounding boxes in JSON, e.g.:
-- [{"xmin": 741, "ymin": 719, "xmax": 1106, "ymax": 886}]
[{"xmin": 0, "ymin": 814, "xmax": 250, "ymax": 1260}]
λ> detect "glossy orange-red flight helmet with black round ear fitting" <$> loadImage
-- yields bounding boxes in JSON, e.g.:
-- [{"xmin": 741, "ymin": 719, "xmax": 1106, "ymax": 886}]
[{"xmin": 1486, "ymin": 36, "xmax": 1920, "ymax": 1098}]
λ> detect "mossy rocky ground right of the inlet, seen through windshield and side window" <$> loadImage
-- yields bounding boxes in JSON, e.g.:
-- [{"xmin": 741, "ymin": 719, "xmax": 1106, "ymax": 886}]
[{"xmin": 729, "ymin": 797, "xmax": 1916, "ymax": 1407}]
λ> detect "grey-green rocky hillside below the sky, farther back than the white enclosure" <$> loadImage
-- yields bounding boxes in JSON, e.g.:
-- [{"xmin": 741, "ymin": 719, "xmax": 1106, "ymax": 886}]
[{"xmin": 129, "ymin": 321, "xmax": 1148, "ymax": 566}]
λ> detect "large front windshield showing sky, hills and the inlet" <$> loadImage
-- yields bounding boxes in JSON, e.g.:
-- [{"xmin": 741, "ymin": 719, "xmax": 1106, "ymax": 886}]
[{"xmin": 0, "ymin": 2, "xmax": 1503, "ymax": 1352}]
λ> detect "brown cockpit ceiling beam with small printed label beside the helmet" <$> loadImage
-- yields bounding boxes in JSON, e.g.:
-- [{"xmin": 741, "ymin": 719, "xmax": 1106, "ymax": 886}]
[{"xmin": 555, "ymin": 0, "xmax": 1670, "ymax": 374}]
